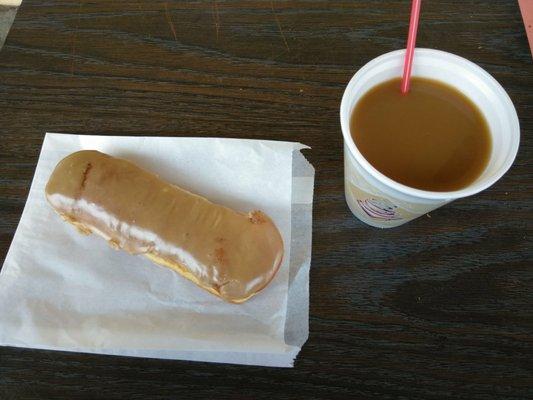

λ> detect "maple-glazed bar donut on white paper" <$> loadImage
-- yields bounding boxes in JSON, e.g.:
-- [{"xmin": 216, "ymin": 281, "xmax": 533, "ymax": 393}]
[{"xmin": 46, "ymin": 150, "xmax": 283, "ymax": 303}]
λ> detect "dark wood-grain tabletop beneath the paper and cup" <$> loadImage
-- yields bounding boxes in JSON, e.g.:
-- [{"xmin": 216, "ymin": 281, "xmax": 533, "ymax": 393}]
[{"xmin": 0, "ymin": 0, "xmax": 533, "ymax": 399}]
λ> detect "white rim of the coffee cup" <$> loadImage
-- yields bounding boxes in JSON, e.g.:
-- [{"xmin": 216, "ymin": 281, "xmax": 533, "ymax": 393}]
[{"xmin": 340, "ymin": 48, "xmax": 520, "ymax": 200}]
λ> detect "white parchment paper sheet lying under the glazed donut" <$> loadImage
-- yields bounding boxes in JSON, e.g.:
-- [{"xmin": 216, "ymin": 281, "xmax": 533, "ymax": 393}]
[{"xmin": 0, "ymin": 134, "xmax": 314, "ymax": 367}]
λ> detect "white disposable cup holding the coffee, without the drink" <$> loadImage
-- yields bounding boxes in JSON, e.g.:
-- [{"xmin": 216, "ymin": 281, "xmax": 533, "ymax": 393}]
[{"xmin": 340, "ymin": 49, "xmax": 520, "ymax": 228}]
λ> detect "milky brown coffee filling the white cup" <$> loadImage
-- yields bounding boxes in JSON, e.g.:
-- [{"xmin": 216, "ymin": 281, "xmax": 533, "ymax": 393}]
[{"xmin": 350, "ymin": 77, "xmax": 492, "ymax": 191}]
